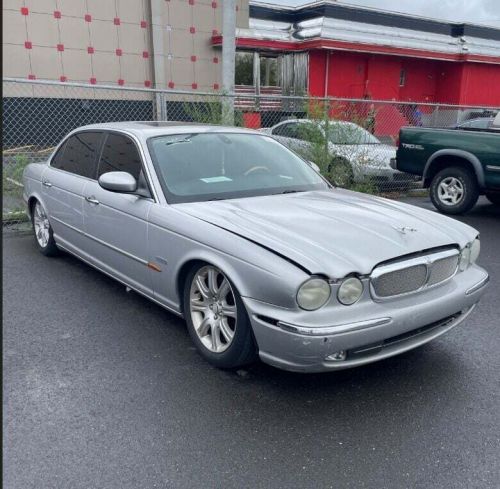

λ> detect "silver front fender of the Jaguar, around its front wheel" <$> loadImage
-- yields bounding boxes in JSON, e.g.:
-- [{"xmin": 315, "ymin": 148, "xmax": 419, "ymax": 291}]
[{"xmin": 148, "ymin": 205, "xmax": 309, "ymax": 311}]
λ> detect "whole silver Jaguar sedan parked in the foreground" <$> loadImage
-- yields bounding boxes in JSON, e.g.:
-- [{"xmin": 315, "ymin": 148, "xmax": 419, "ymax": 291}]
[{"xmin": 24, "ymin": 122, "xmax": 488, "ymax": 372}]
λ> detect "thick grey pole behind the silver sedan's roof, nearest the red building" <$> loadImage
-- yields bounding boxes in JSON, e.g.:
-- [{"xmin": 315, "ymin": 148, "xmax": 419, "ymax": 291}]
[{"xmin": 222, "ymin": 0, "xmax": 236, "ymax": 126}]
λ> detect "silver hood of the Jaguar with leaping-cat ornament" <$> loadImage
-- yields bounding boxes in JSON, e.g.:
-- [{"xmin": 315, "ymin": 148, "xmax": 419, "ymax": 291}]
[{"xmin": 176, "ymin": 189, "xmax": 477, "ymax": 278}]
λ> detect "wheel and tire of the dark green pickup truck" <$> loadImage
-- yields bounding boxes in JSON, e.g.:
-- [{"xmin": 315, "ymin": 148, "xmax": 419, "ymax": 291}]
[{"xmin": 430, "ymin": 166, "xmax": 479, "ymax": 214}]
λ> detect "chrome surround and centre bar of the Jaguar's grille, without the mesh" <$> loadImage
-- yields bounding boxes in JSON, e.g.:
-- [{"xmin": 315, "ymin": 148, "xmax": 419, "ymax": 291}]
[{"xmin": 370, "ymin": 248, "xmax": 460, "ymax": 302}]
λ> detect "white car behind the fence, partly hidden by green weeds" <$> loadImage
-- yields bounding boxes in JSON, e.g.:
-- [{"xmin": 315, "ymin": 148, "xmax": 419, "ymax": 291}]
[{"xmin": 261, "ymin": 119, "xmax": 416, "ymax": 187}]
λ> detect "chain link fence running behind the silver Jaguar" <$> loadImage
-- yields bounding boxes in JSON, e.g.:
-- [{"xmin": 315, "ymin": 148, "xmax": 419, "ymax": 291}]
[{"xmin": 2, "ymin": 79, "xmax": 499, "ymax": 226}]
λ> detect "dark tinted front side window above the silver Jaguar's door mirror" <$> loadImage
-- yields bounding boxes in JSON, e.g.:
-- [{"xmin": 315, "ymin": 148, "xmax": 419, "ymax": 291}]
[{"xmin": 99, "ymin": 134, "xmax": 141, "ymax": 180}]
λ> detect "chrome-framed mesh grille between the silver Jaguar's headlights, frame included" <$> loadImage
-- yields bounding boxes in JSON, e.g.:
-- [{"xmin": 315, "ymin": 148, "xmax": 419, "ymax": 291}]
[{"xmin": 371, "ymin": 248, "xmax": 459, "ymax": 299}]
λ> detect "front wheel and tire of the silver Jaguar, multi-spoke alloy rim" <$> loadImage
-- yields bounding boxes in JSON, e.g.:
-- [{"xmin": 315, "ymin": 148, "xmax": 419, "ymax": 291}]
[{"xmin": 183, "ymin": 264, "xmax": 256, "ymax": 369}]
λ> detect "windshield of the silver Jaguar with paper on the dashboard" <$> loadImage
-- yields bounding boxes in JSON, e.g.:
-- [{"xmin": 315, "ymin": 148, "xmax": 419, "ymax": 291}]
[{"xmin": 148, "ymin": 132, "xmax": 329, "ymax": 203}]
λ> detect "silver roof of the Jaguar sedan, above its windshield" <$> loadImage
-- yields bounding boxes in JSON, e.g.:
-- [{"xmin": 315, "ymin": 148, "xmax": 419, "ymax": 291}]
[{"xmin": 75, "ymin": 121, "xmax": 262, "ymax": 137}]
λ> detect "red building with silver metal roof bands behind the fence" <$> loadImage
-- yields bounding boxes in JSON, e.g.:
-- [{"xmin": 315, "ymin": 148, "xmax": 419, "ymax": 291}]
[{"xmin": 218, "ymin": 2, "xmax": 500, "ymax": 107}]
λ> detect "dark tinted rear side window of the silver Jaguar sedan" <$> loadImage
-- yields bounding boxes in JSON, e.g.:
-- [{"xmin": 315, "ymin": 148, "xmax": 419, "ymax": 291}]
[{"xmin": 51, "ymin": 132, "xmax": 102, "ymax": 178}]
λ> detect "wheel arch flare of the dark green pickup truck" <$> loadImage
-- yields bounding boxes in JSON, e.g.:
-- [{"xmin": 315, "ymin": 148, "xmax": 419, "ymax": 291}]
[{"xmin": 423, "ymin": 149, "xmax": 485, "ymax": 189}]
